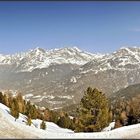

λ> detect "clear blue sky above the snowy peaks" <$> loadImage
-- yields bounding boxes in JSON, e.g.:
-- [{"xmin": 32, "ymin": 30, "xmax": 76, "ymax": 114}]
[{"xmin": 0, "ymin": 1, "xmax": 140, "ymax": 54}]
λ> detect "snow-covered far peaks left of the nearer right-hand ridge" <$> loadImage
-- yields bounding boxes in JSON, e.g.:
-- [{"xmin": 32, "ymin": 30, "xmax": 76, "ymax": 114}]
[{"xmin": 0, "ymin": 47, "xmax": 103, "ymax": 72}]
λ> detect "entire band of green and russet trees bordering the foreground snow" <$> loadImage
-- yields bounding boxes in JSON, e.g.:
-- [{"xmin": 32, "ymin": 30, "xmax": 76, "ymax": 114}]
[{"xmin": 0, "ymin": 87, "xmax": 140, "ymax": 132}]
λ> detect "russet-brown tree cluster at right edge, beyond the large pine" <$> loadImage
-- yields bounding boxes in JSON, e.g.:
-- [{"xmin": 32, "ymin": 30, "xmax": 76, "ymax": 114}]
[{"xmin": 112, "ymin": 95, "xmax": 140, "ymax": 128}]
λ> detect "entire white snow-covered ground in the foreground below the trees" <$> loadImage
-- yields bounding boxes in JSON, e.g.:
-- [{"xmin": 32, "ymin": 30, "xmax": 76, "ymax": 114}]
[{"xmin": 0, "ymin": 104, "xmax": 140, "ymax": 139}]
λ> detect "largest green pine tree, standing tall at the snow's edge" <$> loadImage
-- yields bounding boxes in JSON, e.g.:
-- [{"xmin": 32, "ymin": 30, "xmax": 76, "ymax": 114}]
[{"xmin": 75, "ymin": 87, "xmax": 109, "ymax": 132}]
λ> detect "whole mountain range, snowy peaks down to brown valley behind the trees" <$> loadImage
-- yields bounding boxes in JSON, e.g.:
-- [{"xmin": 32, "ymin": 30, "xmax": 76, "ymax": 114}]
[{"xmin": 0, "ymin": 47, "xmax": 140, "ymax": 109}]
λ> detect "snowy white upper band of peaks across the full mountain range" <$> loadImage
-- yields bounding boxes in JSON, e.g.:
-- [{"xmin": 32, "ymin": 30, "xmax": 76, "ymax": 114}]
[{"xmin": 0, "ymin": 47, "xmax": 140, "ymax": 72}]
